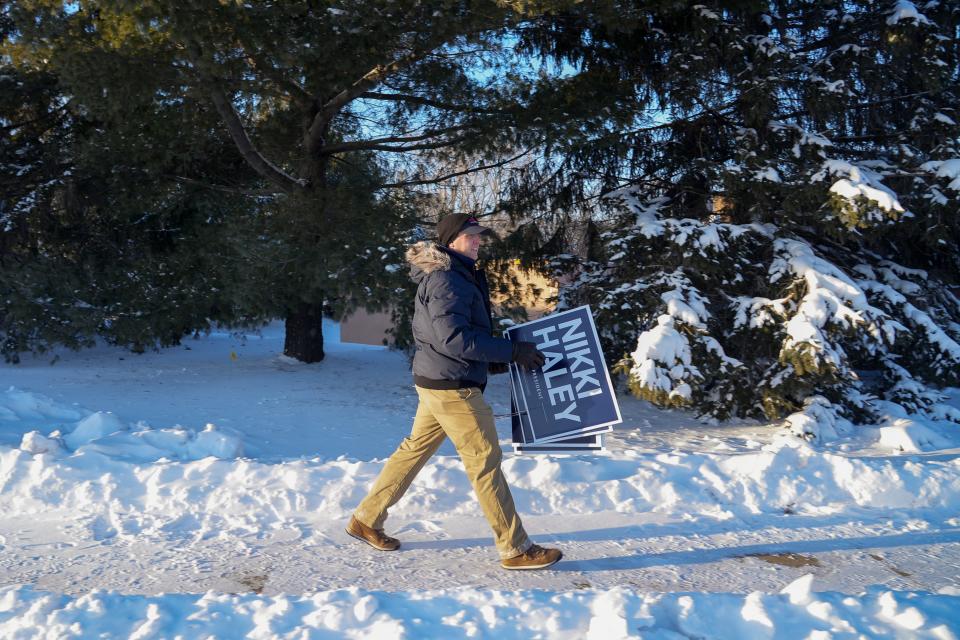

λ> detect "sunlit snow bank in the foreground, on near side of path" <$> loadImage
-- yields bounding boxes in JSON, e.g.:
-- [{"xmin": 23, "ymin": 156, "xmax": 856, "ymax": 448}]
[{"xmin": 0, "ymin": 577, "xmax": 960, "ymax": 640}]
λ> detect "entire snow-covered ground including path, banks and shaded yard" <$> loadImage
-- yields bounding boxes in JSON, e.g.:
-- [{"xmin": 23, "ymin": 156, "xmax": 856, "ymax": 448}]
[{"xmin": 0, "ymin": 323, "xmax": 960, "ymax": 639}]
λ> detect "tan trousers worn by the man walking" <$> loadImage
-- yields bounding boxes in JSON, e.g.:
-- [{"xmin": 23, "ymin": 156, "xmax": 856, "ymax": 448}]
[{"xmin": 354, "ymin": 387, "xmax": 532, "ymax": 558}]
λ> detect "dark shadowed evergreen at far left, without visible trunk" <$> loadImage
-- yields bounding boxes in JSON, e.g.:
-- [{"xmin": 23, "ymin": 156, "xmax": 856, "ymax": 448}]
[{"xmin": 0, "ymin": 58, "xmax": 266, "ymax": 360}]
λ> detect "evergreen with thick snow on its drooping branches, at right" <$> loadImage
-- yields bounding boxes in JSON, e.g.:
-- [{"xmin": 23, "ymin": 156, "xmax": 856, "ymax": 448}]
[{"xmin": 506, "ymin": 0, "xmax": 960, "ymax": 437}]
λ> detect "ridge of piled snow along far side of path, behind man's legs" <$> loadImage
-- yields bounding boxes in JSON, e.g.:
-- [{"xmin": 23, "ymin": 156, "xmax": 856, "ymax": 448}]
[{"xmin": 0, "ymin": 438, "xmax": 960, "ymax": 539}]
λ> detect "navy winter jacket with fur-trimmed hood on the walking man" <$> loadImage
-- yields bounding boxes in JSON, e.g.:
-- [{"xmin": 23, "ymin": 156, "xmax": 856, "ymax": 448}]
[{"xmin": 407, "ymin": 242, "xmax": 513, "ymax": 389}]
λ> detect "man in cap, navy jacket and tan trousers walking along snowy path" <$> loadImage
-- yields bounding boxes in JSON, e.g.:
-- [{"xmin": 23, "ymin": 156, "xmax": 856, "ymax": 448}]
[{"xmin": 347, "ymin": 214, "xmax": 563, "ymax": 569}]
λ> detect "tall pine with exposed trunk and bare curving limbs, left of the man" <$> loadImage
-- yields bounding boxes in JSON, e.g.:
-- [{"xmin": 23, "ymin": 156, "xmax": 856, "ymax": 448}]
[{"xmin": 0, "ymin": 0, "xmax": 556, "ymax": 362}]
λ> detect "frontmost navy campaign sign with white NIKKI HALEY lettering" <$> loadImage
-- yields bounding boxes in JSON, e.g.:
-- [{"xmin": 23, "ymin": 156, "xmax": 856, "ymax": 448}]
[{"xmin": 506, "ymin": 306, "xmax": 621, "ymax": 443}]
